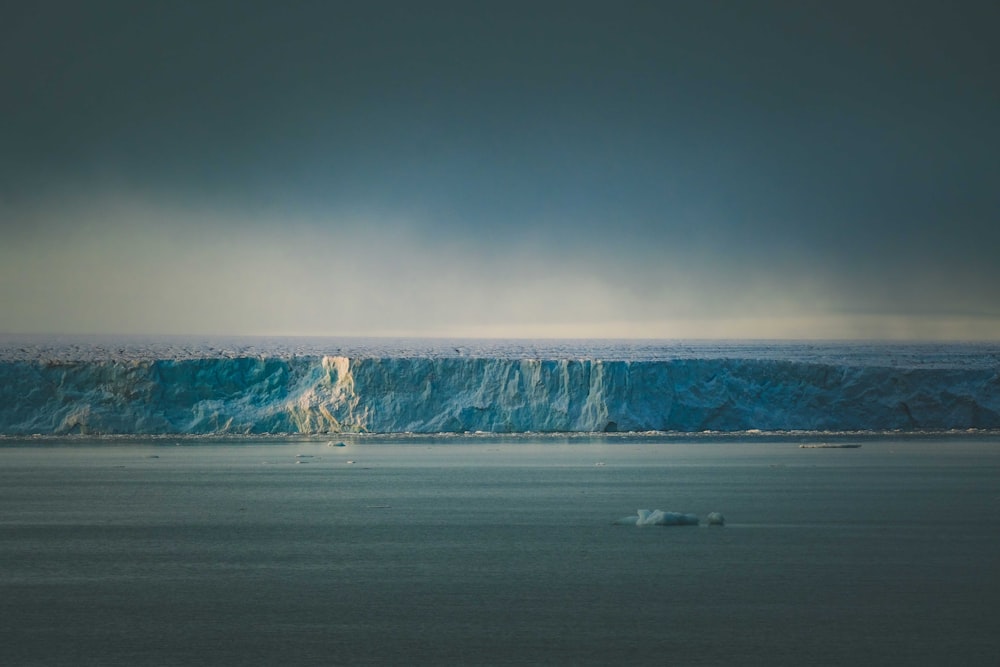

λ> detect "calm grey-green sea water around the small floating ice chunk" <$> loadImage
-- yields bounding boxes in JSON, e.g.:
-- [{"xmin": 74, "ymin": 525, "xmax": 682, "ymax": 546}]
[{"xmin": 0, "ymin": 437, "xmax": 1000, "ymax": 665}]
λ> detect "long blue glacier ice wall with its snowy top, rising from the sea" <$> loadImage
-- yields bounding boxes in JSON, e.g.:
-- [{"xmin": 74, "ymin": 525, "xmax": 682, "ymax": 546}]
[{"xmin": 0, "ymin": 338, "xmax": 1000, "ymax": 435}]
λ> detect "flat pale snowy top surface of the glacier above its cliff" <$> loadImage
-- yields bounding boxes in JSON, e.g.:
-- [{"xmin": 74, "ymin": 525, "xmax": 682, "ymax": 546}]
[{"xmin": 0, "ymin": 335, "xmax": 1000, "ymax": 368}]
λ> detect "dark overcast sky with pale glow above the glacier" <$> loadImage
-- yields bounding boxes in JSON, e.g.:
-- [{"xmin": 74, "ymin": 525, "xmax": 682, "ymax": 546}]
[{"xmin": 0, "ymin": 0, "xmax": 1000, "ymax": 339}]
